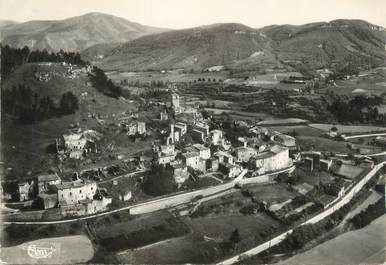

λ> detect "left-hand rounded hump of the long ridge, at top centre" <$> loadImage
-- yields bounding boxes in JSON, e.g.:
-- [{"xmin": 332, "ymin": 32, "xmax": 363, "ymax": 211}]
[{"xmin": 102, "ymin": 24, "xmax": 270, "ymax": 70}]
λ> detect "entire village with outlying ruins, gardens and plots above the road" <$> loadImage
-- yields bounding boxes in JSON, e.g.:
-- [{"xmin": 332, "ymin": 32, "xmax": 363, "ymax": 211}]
[{"xmin": 1, "ymin": 84, "xmax": 378, "ymax": 226}]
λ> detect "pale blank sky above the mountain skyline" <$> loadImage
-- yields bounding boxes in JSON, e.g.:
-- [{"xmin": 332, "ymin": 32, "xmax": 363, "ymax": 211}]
[{"xmin": 0, "ymin": 0, "xmax": 386, "ymax": 29}]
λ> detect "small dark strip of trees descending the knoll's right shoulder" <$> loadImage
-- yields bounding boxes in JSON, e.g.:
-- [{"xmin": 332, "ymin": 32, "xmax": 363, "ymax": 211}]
[{"xmin": 89, "ymin": 66, "xmax": 122, "ymax": 98}]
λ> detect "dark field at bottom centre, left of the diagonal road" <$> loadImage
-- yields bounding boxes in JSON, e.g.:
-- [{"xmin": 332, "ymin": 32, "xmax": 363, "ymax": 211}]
[{"xmin": 116, "ymin": 211, "xmax": 278, "ymax": 264}]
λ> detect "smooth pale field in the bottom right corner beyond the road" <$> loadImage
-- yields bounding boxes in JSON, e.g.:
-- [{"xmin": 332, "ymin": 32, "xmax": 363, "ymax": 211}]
[{"xmin": 278, "ymin": 215, "xmax": 386, "ymax": 265}]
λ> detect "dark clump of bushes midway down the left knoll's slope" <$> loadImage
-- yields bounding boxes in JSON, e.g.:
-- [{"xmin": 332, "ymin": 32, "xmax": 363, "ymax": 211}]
[{"xmin": 1, "ymin": 85, "xmax": 79, "ymax": 123}]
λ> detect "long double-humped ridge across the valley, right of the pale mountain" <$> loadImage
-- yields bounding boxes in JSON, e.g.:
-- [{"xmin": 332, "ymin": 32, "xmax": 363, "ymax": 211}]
[{"xmin": 99, "ymin": 20, "xmax": 386, "ymax": 70}]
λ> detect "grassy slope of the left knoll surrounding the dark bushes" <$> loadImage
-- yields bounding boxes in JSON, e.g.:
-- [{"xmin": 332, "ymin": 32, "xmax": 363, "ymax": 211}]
[{"xmin": 2, "ymin": 64, "xmax": 130, "ymax": 178}]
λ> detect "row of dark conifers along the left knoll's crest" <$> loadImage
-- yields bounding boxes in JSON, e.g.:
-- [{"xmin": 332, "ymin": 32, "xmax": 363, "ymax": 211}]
[{"xmin": 1, "ymin": 45, "xmax": 87, "ymax": 79}]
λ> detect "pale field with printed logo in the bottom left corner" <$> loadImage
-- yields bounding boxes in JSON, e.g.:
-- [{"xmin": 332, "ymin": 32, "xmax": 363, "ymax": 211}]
[{"xmin": 1, "ymin": 235, "xmax": 94, "ymax": 264}]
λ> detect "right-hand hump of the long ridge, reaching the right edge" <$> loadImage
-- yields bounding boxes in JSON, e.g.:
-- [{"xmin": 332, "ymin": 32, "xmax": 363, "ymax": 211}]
[{"xmin": 262, "ymin": 20, "xmax": 386, "ymax": 68}]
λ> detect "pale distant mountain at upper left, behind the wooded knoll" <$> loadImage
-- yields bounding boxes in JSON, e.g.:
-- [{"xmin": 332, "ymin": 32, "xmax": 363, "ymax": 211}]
[{"xmin": 0, "ymin": 13, "xmax": 165, "ymax": 51}]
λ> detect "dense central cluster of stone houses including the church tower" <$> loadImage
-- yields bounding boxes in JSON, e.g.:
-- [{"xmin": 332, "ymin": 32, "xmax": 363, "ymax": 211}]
[{"xmin": 153, "ymin": 93, "xmax": 296, "ymax": 184}]
